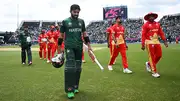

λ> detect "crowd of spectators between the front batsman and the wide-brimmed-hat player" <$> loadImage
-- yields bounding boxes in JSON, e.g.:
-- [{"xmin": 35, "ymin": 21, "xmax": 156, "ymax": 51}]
[{"xmin": 87, "ymin": 19, "xmax": 143, "ymax": 43}]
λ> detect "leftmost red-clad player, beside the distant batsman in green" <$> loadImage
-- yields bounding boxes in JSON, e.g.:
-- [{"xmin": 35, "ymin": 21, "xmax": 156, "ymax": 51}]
[{"xmin": 38, "ymin": 30, "xmax": 47, "ymax": 59}]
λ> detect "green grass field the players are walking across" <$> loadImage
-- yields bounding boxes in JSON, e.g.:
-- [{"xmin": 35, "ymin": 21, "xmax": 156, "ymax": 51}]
[{"xmin": 0, "ymin": 44, "xmax": 180, "ymax": 101}]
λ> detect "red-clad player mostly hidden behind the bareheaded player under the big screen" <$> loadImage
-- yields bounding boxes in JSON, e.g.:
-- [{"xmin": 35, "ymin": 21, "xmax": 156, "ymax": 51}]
[{"xmin": 106, "ymin": 22, "xmax": 116, "ymax": 64}]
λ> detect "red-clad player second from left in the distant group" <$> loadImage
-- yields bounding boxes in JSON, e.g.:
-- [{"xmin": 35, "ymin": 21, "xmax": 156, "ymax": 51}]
[{"xmin": 46, "ymin": 26, "xmax": 57, "ymax": 63}]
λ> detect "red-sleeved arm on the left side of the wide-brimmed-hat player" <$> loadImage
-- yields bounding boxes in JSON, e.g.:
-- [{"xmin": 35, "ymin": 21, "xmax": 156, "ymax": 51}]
[{"xmin": 141, "ymin": 24, "xmax": 147, "ymax": 50}]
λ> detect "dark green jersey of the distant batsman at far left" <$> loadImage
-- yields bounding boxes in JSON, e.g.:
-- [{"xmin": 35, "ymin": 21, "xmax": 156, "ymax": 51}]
[{"xmin": 19, "ymin": 31, "xmax": 32, "ymax": 46}]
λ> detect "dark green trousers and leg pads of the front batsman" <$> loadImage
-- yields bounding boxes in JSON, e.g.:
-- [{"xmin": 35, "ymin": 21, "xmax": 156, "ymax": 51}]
[{"xmin": 64, "ymin": 48, "xmax": 82, "ymax": 93}]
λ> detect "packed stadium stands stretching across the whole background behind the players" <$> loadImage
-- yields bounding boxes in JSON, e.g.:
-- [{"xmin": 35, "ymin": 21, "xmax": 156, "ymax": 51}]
[{"xmin": 0, "ymin": 14, "xmax": 180, "ymax": 44}]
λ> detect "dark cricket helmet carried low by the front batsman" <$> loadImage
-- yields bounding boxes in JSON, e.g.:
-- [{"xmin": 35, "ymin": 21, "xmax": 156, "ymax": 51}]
[{"xmin": 52, "ymin": 53, "xmax": 65, "ymax": 68}]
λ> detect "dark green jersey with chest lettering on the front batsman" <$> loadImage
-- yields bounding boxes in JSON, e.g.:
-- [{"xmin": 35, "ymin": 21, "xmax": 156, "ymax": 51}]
[{"xmin": 60, "ymin": 17, "xmax": 86, "ymax": 48}]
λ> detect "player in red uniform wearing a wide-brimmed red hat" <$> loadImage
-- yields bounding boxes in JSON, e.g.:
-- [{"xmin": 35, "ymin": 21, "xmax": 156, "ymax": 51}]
[{"xmin": 141, "ymin": 13, "xmax": 168, "ymax": 77}]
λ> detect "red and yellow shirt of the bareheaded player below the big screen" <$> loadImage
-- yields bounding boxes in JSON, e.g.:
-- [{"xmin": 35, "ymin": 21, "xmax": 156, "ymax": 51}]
[{"xmin": 112, "ymin": 24, "xmax": 125, "ymax": 44}]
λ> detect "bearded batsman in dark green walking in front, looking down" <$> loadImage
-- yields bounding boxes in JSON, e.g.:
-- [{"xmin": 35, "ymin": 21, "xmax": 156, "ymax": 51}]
[{"xmin": 54, "ymin": 4, "xmax": 91, "ymax": 99}]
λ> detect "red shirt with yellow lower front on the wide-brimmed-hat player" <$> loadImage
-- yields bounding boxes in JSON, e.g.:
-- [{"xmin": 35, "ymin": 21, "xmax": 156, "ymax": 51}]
[{"xmin": 142, "ymin": 21, "xmax": 166, "ymax": 45}]
